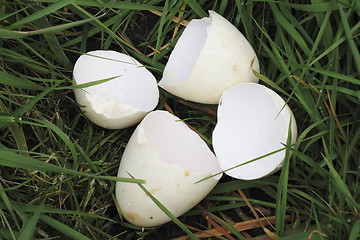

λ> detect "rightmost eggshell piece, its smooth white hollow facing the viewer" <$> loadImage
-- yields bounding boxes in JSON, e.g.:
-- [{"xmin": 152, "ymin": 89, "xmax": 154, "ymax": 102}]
[{"xmin": 213, "ymin": 83, "xmax": 297, "ymax": 180}]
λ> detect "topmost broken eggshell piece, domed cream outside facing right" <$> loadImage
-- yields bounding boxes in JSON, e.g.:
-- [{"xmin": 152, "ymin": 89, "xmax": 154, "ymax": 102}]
[{"xmin": 159, "ymin": 11, "xmax": 260, "ymax": 104}]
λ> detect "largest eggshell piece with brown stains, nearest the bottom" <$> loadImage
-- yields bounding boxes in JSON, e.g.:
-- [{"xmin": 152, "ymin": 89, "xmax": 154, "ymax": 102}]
[{"xmin": 116, "ymin": 111, "xmax": 221, "ymax": 227}]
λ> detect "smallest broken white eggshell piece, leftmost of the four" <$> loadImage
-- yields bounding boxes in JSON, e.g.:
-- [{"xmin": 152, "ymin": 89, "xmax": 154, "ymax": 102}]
[{"xmin": 73, "ymin": 50, "xmax": 159, "ymax": 129}]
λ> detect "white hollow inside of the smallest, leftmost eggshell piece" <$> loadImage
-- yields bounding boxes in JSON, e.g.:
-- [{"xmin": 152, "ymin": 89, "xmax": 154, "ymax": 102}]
[{"xmin": 73, "ymin": 50, "xmax": 159, "ymax": 112}]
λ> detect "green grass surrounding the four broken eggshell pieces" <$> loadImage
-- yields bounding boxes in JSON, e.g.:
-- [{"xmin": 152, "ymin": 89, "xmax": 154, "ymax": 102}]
[{"xmin": 0, "ymin": 0, "xmax": 360, "ymax": 240}]
